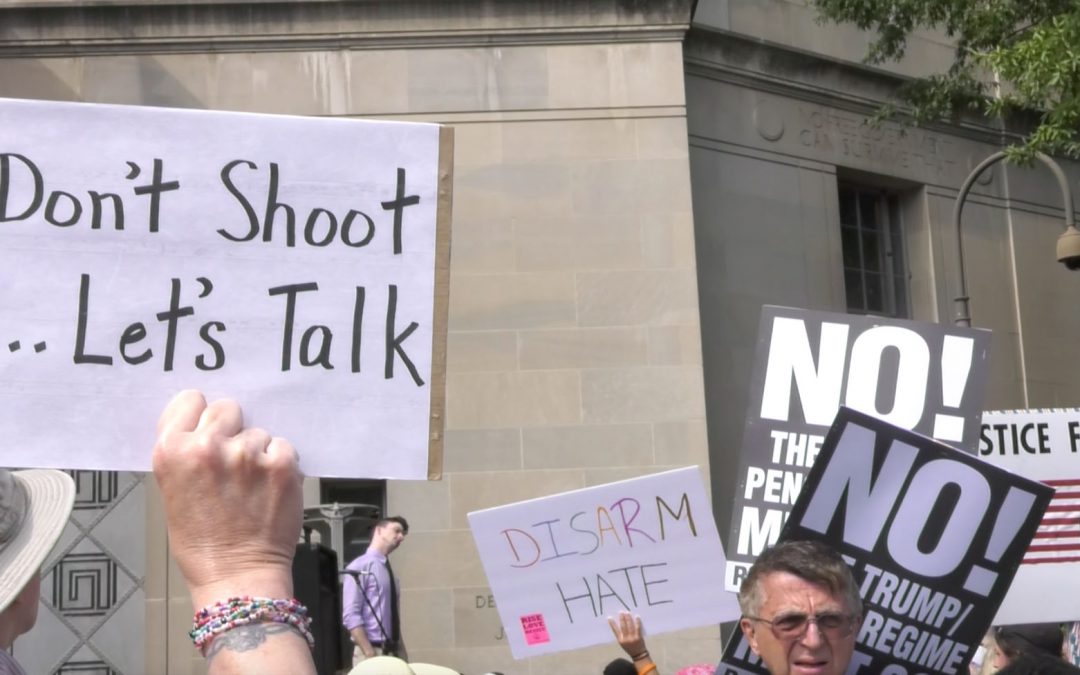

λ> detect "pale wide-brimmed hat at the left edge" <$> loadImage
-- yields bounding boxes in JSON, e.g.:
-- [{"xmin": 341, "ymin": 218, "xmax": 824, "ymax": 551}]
[{"xmin": 0, "ymin": 469, "xmax": 75, "ymax": 611}]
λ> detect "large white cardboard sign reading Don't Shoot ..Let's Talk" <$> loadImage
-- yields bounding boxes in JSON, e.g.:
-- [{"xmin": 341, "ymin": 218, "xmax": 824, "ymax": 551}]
[{"xmin": 0, "ymin": 100, "xmax": 451, "ymax": 478}]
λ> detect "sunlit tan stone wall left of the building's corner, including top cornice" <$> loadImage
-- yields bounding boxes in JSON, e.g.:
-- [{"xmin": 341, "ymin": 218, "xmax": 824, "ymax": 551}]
[{"xmin": 0, "ymin": 0, "xmax": 719, "ymax": 675}]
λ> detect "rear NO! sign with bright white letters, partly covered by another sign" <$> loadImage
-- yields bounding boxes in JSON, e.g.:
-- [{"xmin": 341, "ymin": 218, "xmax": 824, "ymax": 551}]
[{"xmin": 725, "ymin": 307, "xmax": 989, "ymax": 591}]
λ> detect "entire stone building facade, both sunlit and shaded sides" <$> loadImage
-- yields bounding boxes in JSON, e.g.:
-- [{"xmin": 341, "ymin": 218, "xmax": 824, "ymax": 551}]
[{"xmin": 0, "ymin": 0, "xmax": 1080, "ymax": 675}]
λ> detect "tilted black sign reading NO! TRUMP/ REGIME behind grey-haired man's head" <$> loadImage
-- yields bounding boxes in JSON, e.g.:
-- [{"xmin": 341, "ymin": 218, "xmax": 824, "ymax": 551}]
[{"xmin": 717, "ymin": 408, "xmax": 1053, "ymax": 675}]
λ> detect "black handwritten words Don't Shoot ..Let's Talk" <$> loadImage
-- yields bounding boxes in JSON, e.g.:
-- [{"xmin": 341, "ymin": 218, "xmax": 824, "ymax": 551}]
[{"xmin": 0, "ymin": 152, "xmax": 426, "ymax": 387}]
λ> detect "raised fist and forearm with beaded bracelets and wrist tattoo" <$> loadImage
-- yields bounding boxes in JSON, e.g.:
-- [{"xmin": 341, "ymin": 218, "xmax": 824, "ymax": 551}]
[{"xmin": 152, "ymin": 390, "xmax": 315, "ymax": 675}]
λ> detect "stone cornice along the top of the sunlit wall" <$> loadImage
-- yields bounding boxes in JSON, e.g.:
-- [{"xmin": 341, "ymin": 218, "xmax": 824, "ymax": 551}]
[{"xmin": 0, "ymin": 0, "xmax": 691, "ymax": 56}]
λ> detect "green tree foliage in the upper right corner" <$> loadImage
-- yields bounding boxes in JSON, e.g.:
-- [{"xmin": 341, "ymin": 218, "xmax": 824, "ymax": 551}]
[{"xmin": 814, "ymin": 0, "xmax": 1080, "ymax": 162}]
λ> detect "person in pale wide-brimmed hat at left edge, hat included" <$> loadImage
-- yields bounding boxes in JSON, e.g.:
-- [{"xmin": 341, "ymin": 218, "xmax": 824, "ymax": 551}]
[{"xmin": 0, "ymin": 469, "xmax": 75, "ymax": 675}]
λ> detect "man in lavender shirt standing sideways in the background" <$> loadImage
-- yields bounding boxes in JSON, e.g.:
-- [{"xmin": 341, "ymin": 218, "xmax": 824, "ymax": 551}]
[{"xmin": 341, "ymin": 515, "xmax": 408, "ymax": 665}]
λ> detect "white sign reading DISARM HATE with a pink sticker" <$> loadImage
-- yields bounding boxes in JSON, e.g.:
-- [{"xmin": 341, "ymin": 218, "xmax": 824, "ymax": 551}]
[{"xmin": 469, "ymin": 467, "xmax": 739, "ymax": 659}]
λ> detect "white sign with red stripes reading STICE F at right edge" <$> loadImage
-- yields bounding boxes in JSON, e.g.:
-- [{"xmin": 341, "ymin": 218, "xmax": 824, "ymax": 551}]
[{"xmin": 978, "ymin": 408, "xmax": 1080, "ymax": 624}]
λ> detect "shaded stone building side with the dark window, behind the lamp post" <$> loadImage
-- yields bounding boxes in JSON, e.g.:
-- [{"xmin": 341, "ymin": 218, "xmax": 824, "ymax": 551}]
[{"xmin": 685, "ymin": 0, "xmax": 1080, "ymax": 531}]
